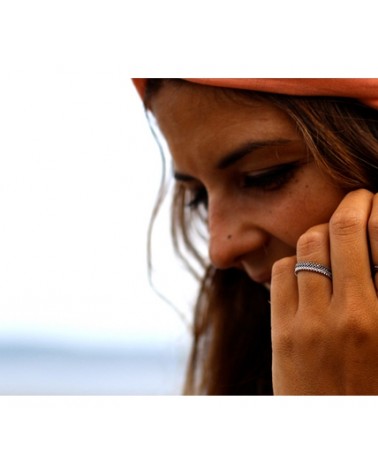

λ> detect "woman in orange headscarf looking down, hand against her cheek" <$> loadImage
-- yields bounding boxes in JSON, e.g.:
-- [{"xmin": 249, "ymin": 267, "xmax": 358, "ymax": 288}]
[{"xmin": 134, "ymin": 79, "xmax": 378, "ymax": 395}]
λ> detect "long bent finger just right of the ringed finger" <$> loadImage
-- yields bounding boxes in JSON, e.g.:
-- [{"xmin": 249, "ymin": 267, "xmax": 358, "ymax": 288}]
[{"xmin": 329, "ymin": 190, "xmax": 373, "ymax": 297}]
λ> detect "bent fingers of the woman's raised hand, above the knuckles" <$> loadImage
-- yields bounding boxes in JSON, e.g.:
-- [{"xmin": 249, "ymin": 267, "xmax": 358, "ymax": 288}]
[{"xmin": 271, "ymin": 189, "xmax": 378, "ymax": 326}]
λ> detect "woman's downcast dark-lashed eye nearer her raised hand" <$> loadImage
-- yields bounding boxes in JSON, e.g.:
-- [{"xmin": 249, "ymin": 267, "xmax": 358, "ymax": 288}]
[{"xmin": 242, "ymin": 162, "xmax": 300, "ymax": 192}]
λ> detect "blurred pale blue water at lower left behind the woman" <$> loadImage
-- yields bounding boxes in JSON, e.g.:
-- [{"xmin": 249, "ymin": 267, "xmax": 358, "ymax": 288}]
[{"xmin": 0, "ymin": 338, "xmax": 187, "ymax": 395}]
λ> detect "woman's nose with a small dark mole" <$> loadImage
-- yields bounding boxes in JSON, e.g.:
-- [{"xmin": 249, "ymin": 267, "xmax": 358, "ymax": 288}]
[{"xmin": 208, "ymin": 197, "xmax": 269, "ymax": 269}]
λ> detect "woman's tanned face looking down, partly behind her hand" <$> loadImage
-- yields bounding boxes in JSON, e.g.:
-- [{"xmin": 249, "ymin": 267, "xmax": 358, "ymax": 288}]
[{"xmin": 151, "ymin": 83, "xmax": 345, "ymax": 285}]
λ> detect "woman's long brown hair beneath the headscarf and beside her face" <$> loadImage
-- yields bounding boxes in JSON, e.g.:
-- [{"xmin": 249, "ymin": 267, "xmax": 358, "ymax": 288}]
[{"xmin": 145, "ymin": 79, "xmax": 378, "ymax": 395}]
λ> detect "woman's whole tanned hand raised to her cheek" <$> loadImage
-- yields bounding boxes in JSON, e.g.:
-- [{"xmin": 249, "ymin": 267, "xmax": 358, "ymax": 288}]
[{"xmin": 271, "ymin": 190, "xmax": 378, "ymax": 395}]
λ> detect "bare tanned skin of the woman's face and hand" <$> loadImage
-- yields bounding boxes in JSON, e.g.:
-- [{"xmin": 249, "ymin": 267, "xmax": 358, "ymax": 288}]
[{"xmin": 151, "ymin": 84, "xmax": 378, "ymax": 395}]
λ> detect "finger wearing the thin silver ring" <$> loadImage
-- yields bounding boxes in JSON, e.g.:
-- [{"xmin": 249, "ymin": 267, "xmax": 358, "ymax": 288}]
[{"xmin": 297, "ymin": 224, "xmax": 332, "ymax": 303}]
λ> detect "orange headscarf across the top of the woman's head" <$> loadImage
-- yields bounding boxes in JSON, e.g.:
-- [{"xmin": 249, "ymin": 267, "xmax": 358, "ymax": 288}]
[{"xmin": 133, "ymin": 79, "xmax": 378, "ymax": 109}]
